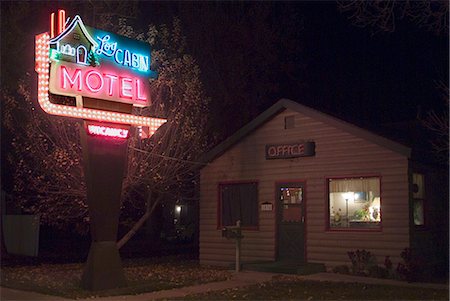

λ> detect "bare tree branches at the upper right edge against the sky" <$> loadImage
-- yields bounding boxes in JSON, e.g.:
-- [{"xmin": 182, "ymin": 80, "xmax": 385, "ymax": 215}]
[{"xmin": 338, "ymin": 0, "xmax": 449, "ymax": 164}]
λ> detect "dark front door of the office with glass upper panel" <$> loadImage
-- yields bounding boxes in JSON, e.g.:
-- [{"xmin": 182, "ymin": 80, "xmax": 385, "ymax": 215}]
[{"xmin": 277, "ymin": 182, "xmax": 305, "ymax": 262}]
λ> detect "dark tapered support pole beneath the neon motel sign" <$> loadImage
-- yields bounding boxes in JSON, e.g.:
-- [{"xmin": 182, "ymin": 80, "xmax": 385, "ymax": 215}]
[{"xmin": 80, "ymin": 121, "xmax": 130, "ymax": 290}]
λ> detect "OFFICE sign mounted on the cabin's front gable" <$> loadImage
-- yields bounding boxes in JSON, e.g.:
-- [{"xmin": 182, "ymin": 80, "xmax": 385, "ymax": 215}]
[{"xmin": 266, "ymin": 141, "xmax": 316, "ymax": 159}]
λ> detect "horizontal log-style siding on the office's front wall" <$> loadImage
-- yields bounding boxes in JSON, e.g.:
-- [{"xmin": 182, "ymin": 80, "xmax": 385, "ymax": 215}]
[{"xmin": 200, "ymin": 109, "xmax": 409, "ymax": 265}]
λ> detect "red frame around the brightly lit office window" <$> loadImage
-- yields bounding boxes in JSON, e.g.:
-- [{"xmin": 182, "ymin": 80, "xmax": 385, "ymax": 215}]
[{"xmin": 325, "ymin": 174, "xmax": 383, "ymax": 232}]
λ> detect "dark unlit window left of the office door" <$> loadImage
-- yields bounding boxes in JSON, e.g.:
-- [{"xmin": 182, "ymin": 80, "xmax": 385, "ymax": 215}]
[{"xmin": 219, "ymin": 182, "xmax": 258, "ymax": 227}]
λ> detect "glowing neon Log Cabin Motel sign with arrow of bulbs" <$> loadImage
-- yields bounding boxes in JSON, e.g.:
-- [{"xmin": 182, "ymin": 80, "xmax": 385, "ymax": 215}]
[{"xmin": 35, "ymin": 10, "xmax": 167, "ymax": 138}]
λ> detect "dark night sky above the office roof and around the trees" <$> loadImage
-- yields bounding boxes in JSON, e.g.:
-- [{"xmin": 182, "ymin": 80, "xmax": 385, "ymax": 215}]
[{"xmin": 2, "ymin": 1, "xmax": 449, "ymax": 140}]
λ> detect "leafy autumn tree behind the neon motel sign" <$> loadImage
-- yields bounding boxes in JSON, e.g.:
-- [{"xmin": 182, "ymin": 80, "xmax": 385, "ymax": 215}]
[{"xmin": 2, "ymin": 19, "xmax": 208, "ymax": 246}]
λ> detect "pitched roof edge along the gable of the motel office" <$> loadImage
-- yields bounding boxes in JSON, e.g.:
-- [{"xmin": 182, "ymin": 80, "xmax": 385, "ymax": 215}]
[{"xmin": 201, "ymin": 99, "xmax": 411, "ymax": 163}]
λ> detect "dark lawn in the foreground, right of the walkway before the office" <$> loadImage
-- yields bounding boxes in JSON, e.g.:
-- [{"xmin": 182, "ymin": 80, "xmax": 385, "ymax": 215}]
[{"xmin": 183, "ymin": 275, "xmax": 449, "ymax": 300}]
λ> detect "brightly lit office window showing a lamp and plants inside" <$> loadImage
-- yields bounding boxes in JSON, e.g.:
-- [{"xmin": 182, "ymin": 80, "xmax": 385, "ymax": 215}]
[{"xmin": 328, "ymin": 177, "xmax": 381, "ymax": 229}]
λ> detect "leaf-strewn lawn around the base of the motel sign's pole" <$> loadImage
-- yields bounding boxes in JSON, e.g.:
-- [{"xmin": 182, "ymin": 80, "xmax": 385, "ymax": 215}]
[{"xmin": 1, "ymin": 258, "xmax": 231, "ymax": 299}]
